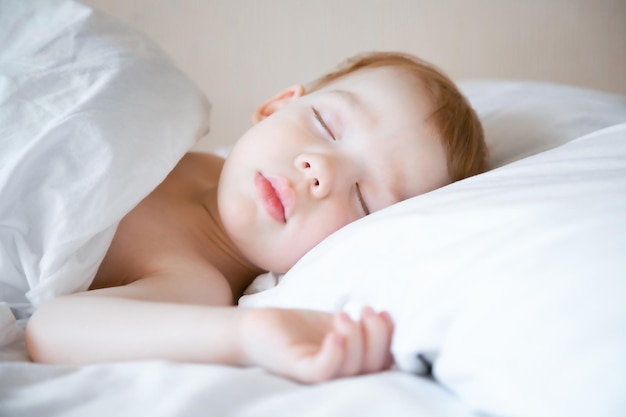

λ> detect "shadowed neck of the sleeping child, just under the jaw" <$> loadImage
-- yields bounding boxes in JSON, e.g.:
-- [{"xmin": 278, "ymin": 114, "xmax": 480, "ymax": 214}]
[{"xmin": 196, "ymin": 187, "xmax": 265, "ymax": 301}]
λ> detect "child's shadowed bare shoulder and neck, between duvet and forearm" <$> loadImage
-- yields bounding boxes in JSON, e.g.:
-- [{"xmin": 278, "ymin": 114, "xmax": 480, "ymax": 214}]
[{"xmin": 91, "ymin": 153, "xmax": 260, "ymax": 295}]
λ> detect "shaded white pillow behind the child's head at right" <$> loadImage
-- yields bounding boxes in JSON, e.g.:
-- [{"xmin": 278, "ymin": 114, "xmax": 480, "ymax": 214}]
[{"xmin": 459, "ymin": 80, "xmax": 626, "ymax": 168}]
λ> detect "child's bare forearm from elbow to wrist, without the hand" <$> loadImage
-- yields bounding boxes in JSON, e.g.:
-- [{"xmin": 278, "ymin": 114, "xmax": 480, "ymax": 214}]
[{"xmin": 26, "ymin": 287, "xmax": 243, "ymax": 364}]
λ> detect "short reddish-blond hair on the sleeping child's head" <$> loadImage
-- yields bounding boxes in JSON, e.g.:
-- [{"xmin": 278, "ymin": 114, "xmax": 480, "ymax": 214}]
[{"xmin": 310, "ymin": 52, "xmax": 488, "ymax": 182}]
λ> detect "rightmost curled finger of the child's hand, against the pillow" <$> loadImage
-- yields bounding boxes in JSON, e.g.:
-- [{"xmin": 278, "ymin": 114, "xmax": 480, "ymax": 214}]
[{"xmin": 361, "ymin": 307, "xmax": 391, "ymax": 373}]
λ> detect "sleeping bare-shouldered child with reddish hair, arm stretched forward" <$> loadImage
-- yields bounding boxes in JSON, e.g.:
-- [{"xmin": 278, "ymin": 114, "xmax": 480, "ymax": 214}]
[{"xmin": 26, "ymin": 52, "xmax": 486, "ymax": 383}]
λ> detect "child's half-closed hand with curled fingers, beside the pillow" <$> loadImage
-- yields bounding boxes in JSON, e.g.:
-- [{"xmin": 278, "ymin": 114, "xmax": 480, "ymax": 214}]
[{"xmin": 241, "ymin": 307, "xmax": 393, "ymax": 383}]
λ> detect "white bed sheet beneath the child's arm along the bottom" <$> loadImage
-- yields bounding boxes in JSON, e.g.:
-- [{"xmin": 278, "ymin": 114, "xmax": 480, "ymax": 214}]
[{"xmin": 0, "ymin": 362, "xmax": 475, "ymax": 417}]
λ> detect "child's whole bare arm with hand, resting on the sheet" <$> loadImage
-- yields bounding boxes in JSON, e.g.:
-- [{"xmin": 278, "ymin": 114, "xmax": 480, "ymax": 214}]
[{"xmin": 26, "ymin": 277, "xmax": 392, "ymax": 382}]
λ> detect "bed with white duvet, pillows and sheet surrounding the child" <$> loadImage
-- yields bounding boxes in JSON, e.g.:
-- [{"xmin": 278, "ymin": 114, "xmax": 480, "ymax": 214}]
[{"xmin": 0, "ymin": 0, "xmax": 626, "ymax": 417}]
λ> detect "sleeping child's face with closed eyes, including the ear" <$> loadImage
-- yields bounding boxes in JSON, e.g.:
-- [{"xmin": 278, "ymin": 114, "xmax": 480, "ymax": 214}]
[{"xmin": 218, "ymin": 67, "xmax": 450, "ymax": 272}]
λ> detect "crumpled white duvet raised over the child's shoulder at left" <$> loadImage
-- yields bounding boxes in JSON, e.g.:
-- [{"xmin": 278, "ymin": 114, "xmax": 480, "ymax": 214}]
[{"xmin": 0, "ymin": 0, "xmax": 209, "ymax": 315}]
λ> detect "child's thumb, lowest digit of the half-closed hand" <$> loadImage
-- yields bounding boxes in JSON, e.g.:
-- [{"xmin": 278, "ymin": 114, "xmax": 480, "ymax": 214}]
[{"xmin": 294, "ymin": 332, "xmax": 346, "ymax": 383}]
